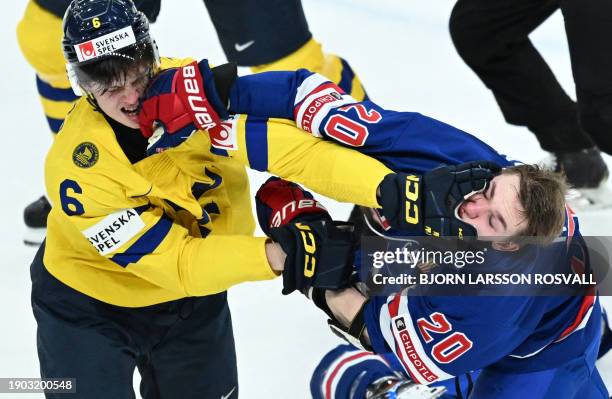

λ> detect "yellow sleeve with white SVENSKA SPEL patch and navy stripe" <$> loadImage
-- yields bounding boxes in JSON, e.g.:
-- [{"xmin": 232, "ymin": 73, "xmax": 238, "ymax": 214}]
[{"xmin": 52, "ymin": 178, "xmax": 276, "ymax": 297}]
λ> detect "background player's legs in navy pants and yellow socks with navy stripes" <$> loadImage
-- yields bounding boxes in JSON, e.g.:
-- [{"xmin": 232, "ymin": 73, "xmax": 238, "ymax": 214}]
[{"xmin": 17, "ymin": 0, "xmax": 366, "ymax": 245}]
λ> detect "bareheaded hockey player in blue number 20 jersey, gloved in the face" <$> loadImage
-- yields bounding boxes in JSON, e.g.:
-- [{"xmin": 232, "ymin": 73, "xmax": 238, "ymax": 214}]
[{"xmin": 137, "ymin": 66, "xmax": 607, "ymax": 398}]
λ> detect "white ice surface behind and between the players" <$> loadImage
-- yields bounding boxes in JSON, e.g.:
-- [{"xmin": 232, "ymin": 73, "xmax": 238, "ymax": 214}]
[{"xmin": 0, "ymin": 0, "xmax": 612, "ymax": 399}]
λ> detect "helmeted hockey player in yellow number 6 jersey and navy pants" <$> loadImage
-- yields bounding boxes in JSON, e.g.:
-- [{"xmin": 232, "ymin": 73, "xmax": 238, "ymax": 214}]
[{"xmin": 31, "ymin": 0, "xmax": 391, "ymax": 398}]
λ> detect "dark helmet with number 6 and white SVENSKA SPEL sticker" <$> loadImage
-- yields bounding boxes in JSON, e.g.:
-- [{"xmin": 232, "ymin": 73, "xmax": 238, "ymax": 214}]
[{"xmin": 62, "ymin": 0, "xmax": 159, "ymax": 91}]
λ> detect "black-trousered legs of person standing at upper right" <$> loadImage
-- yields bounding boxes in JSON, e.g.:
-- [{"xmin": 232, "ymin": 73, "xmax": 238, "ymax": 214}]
[{"xmin": 450, "ymin": 0, "xmax": 612, "ymax": 211}]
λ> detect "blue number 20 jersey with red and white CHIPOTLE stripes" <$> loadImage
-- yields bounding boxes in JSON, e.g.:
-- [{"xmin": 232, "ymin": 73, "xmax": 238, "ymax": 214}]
[{"xmin": 230, "ymin": 70, "xmax": 601, "ymax": 384}]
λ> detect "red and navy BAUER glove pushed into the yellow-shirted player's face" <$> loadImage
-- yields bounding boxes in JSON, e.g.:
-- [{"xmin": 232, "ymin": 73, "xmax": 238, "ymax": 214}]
[{"xmin": 138, "ymin": 60, "xmax": 236, "ymax": 155}]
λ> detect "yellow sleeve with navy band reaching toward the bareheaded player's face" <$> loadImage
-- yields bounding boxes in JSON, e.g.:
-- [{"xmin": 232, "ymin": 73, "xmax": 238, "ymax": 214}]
[{"xmin": 228, "ymin": 115, "xmax": 392, "ymax": 207}]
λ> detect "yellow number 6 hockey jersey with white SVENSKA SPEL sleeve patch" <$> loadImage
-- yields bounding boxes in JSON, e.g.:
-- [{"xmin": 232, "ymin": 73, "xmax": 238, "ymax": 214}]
[{"xmin": 44, "ymin": 57, "xmax": 391, "ymax": 307}]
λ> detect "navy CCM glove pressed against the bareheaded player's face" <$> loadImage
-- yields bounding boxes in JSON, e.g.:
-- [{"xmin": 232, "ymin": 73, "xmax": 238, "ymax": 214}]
[{"xmin": 380, "ymin": 161, "xmax": 501, "ymax": 238}]
